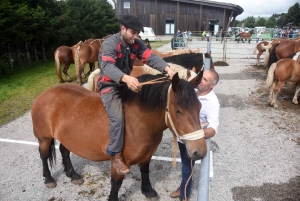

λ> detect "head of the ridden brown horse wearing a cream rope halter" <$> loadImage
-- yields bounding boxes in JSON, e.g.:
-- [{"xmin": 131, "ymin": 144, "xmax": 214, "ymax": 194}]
[{"xmin": 166, "ymin": 73, "xmax": 207, "ymax": 160}]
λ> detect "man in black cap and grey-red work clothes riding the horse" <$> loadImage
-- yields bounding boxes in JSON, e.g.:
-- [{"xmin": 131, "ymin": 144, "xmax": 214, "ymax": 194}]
[{"xmin": 98, "ymin": 15, "xmax": 175, "ymax": 175}]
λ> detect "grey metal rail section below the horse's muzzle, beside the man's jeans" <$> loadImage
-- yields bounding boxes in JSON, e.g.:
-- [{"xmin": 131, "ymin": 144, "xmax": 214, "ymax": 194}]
[{"xmin": 197, "ymin": 138, "xmax": 211, "ymax": 201}]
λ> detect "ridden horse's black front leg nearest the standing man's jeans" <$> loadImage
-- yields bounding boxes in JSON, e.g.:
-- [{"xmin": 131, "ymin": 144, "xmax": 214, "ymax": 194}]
[{"xmin": 140, "ymin": 159, "xmax": 157, "ymax": 198}]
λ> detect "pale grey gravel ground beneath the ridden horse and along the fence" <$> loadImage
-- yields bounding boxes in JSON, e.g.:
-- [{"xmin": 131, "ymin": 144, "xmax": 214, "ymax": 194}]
[{"xmin": 0, "ymin": 41, "xmax": 300, "ymax": 201}]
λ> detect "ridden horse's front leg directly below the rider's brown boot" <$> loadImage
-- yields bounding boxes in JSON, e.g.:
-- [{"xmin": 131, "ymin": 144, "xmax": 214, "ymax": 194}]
[{"xmin": 108, "ymin": 164, "xmax": 125, "ymax": 201}]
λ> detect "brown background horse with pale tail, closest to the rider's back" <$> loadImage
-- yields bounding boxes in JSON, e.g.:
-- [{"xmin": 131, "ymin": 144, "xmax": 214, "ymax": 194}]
[{"xmin": 72, "ymin": 39, "xmax": 104, "ymax": 84}]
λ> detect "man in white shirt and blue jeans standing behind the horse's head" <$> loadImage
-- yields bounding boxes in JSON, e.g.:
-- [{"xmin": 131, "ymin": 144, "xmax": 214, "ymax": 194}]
[{"xmin": 170, "ymin": 70, "xmax": 220, "ymax": 201}]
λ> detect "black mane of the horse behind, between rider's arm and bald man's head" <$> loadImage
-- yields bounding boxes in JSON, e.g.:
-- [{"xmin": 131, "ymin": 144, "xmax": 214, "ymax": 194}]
[{"xmin": 163, "ymin": 53, "xmax": 204, "ymax": 70}]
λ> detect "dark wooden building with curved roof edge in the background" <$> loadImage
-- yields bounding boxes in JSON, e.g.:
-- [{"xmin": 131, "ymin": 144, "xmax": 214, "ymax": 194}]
[{"xmin": 115, "ymin": 0, "xmax": 244, "ymax": 35}]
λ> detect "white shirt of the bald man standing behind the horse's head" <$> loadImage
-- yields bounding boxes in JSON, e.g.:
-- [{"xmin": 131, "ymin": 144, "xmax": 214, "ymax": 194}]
[{"xmin": 177, "ymin": 89, "xmax": 220, "ymax": 143}]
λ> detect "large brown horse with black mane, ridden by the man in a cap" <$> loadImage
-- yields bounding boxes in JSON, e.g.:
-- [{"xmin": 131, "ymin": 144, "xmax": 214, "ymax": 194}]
[{"xmin": 31, "ymin": 73, "xmax": 207, "ymax": 201}]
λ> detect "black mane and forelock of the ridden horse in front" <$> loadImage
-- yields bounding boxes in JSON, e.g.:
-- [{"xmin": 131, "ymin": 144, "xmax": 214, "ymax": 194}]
[{"xmin": 121, "ymin": 74, "xmax": 199, "ymax": 112}]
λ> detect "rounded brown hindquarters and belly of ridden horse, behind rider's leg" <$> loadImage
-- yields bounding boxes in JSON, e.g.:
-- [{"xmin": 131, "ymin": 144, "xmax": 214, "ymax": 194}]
[{"xmin": 31, "ymin": 84, "xmax": 109, "ymax": 161}]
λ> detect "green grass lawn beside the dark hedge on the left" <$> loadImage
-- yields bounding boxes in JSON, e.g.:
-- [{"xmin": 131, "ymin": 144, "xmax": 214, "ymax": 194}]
[{"xmin": 0, "ymin": 41, "xmax": 169, "ymax": 126}]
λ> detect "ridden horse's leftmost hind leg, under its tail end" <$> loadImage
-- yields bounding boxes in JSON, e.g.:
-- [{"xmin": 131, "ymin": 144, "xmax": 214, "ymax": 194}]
[{"xmin": 39, "ymin": 139, "xmax": 56, "ymax": 188}]
